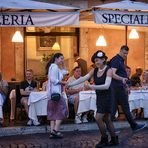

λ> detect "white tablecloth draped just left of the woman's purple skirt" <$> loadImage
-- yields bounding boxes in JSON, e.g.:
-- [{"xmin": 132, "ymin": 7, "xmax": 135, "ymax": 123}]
[{"xmin": 28, "ymin": 91, "xmax": 48, "ymax": 122}]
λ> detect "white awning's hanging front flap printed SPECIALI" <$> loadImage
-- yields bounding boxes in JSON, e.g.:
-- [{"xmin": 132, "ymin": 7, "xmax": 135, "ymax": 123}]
[{"xmin": 94, "ymin": 10, "xmax": 148, "ymax": 26}]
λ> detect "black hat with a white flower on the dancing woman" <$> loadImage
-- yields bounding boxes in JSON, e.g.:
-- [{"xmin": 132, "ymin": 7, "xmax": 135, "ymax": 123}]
[{"xmin": 91, "ymin": 50, "xmax": 108, "ymax": 63}]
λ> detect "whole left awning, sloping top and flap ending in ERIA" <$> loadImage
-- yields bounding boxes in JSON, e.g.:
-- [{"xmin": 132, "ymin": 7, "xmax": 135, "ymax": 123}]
[{"xmin": 0, "ymin": 0, "xmax": 79, "ymax": 27}]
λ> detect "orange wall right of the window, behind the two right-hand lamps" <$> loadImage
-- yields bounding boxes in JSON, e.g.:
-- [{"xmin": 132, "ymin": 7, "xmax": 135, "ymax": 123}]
[{"xmin": 80, "ymin": 28, "xmax": 145, "ymax": 73}]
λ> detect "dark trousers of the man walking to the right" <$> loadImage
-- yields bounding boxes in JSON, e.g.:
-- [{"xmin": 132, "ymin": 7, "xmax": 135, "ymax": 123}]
[{"xmin": 111, "ymin": 86, "xmax": 137, "ymax": 128}]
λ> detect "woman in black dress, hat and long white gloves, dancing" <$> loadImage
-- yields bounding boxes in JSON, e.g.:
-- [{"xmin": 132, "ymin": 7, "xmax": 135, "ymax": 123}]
[{"xmin": 68, "ymin": 50, "xmax": 118, "ymax": 148}]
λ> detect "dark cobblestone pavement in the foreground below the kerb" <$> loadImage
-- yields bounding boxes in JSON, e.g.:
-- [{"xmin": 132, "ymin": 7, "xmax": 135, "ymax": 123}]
[{"xmin": 0, "ymin": 128, "xmax": 148, "ymax": 148}]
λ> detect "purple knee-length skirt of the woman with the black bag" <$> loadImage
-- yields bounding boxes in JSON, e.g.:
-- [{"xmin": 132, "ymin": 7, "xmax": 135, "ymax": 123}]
[{"xmin": 47, "ymin": 98, "xmax": 68, "ymax": 121}]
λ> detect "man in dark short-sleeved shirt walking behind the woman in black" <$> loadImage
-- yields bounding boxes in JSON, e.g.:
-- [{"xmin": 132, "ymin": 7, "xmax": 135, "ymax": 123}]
[{"xmin": 110, "ymin": 45, "xmax": 145, "ymax": 131}]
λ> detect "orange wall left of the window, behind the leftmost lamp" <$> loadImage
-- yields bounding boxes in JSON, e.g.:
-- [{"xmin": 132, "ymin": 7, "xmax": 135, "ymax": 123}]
[{"xmin": 0, "ymin": 27, "xmax": 24, "ymax": 81}]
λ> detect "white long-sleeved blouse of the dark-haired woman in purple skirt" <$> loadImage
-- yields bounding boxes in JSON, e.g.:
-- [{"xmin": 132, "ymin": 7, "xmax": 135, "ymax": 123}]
[{"xmin": 47, "ymin": 63, "xmax": 68, "ymax": 99}]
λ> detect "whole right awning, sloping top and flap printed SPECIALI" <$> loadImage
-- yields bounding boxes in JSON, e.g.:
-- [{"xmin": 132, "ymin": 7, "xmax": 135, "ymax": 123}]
[{"xmin": 93, "ymin": 0, "xmax": 148, "ymax": 26}]
